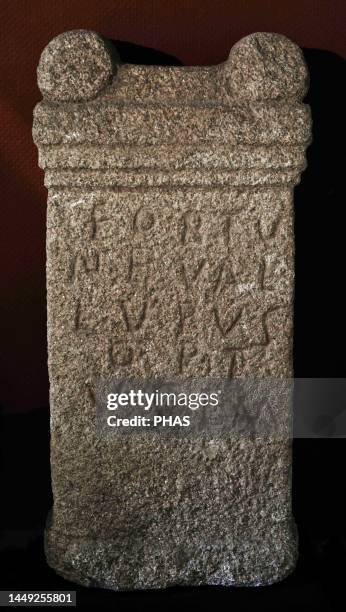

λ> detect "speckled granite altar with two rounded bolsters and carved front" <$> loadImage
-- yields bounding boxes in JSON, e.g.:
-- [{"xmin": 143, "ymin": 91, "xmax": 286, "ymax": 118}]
[{"xmin": 33, "ymin": 30, "xmax": 311, "ymax": 589}]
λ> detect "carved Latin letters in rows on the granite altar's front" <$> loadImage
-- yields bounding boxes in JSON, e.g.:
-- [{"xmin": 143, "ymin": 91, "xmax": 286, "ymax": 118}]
[{"xmin": 67, "ymin": 206, "xmax": 285, "ymax": 378}]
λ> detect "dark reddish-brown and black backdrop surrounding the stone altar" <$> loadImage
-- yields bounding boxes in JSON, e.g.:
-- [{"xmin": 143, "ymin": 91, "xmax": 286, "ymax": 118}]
[{"xmin": 0, "ymin": 0, "xmax": 346, "ymax": 610}]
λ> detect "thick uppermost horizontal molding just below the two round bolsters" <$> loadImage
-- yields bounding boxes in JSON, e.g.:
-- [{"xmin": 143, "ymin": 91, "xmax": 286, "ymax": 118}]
[{"xmin": 33, "ymin": 102, "xmax": 311, "ymax": 146}]
